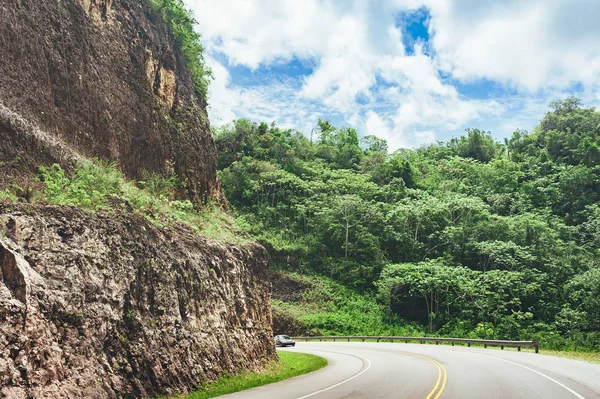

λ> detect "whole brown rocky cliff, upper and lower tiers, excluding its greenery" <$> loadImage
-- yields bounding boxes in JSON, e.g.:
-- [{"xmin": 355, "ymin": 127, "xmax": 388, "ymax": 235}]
[{"xmin": 0, "ymin": 0, "xmax": 276, "ymax": 399}]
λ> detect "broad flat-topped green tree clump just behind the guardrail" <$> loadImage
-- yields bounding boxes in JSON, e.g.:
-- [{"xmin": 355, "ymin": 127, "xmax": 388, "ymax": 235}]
[{"xmin": 377, "ymin": 259, "xmax": 540, "ymax": 337}]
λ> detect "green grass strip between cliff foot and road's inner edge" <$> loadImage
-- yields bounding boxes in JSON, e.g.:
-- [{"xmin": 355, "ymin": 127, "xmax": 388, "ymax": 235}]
[{"xmin": 179, "ymin": 351, "xmax": 327, "ymax": 399}]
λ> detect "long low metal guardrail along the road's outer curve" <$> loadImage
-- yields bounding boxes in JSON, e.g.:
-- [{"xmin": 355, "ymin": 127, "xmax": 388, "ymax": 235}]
[{"xmin": 293, "ymin": 335, "xmax": 540, "ymax": 353}]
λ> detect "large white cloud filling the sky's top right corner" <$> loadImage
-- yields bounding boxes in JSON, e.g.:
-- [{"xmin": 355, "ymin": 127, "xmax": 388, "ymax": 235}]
[{"xmin": 427, "ymin": 0, "xmax": 600, "ymax": 91}]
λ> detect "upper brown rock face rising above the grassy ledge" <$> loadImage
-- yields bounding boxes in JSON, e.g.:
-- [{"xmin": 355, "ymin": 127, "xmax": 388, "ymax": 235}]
[{"xmin": 0, "ymin": 0, "xmax": 223, "ymax": 202}]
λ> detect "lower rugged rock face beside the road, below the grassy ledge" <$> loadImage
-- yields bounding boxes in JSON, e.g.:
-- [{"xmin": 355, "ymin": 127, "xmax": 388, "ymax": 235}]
[{"xmin": 0, "ymin": 204, "xmax": 275, "ymax": 399}]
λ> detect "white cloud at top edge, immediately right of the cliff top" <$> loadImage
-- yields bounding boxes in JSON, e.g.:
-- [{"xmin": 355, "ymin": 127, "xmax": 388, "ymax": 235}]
[{"xmin": 186, "ymin": 0, "xmax": 339, "ymax": 69}]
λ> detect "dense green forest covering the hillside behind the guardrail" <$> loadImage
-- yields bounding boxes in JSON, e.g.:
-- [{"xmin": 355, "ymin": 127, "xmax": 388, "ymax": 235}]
[{"xmin": 214, "ymin": 98, "xmax": 600, "ymax": 349}]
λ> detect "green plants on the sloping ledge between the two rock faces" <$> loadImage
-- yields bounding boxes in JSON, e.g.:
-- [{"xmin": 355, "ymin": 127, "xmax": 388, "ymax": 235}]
[{"xmin": 38, "ymin": 160, "xmax": 248, "ymax": 243}]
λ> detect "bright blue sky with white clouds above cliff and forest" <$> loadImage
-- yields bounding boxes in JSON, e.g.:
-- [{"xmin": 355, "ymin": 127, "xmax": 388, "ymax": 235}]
[{"xmin": 184, "ymin": 0, "xmax": 600, "ymax": 150}]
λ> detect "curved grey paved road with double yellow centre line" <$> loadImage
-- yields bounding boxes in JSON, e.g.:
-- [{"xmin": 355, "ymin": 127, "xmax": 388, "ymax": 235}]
[{"xmin": 223, "ymin": 342, "xmax": 600, "ymax": 399}]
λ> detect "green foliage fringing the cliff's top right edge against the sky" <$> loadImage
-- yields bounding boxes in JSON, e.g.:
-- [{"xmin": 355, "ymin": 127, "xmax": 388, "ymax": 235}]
[{"xmin": 151, "ymin": 0, "xmax": 212, "ymax": 102}]
